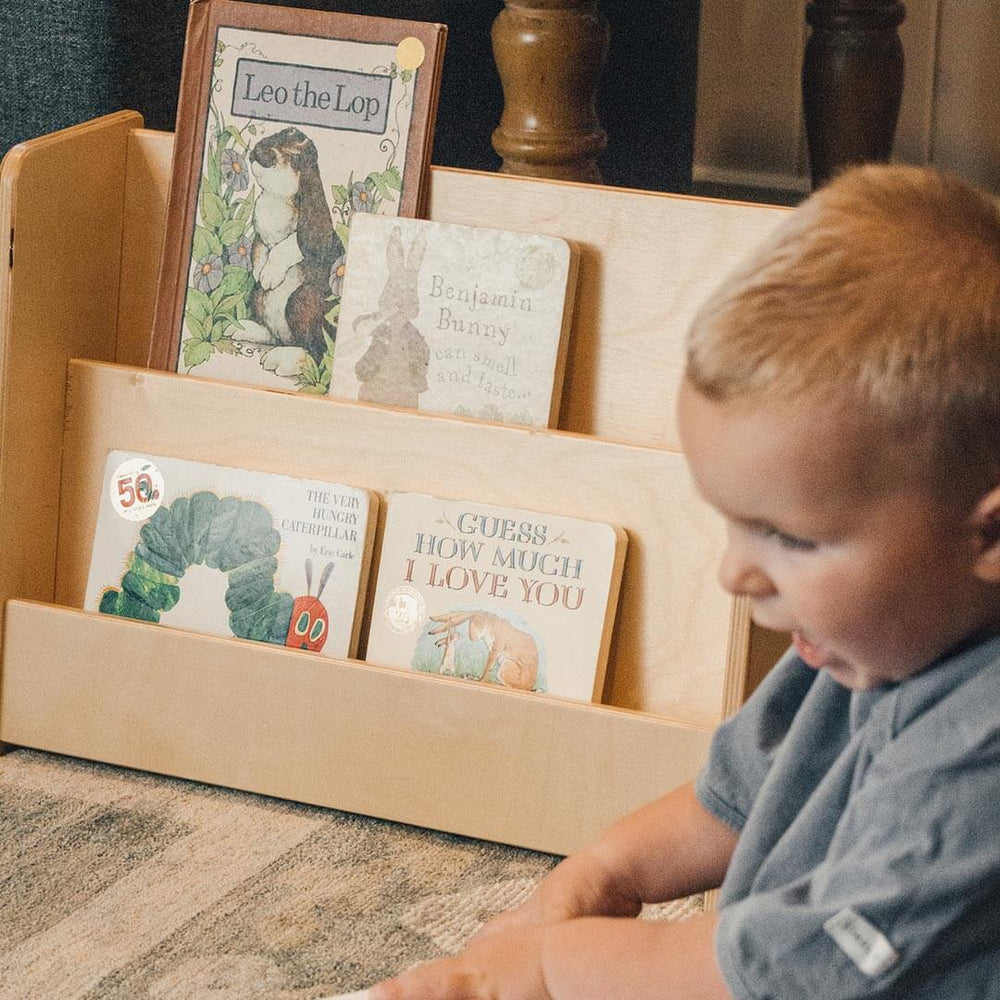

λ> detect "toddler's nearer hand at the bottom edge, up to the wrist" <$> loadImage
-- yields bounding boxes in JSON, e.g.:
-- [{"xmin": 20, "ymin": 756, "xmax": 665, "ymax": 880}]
[{"xmin": 368, "ymin": 926, "xmax": 551, "ymax": 1000}]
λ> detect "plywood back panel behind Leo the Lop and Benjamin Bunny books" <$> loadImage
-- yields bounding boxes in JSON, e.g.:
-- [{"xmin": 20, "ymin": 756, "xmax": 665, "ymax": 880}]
[{"xmin": 117, "ymin": 130, "xmax": 788, "ymax": 450}]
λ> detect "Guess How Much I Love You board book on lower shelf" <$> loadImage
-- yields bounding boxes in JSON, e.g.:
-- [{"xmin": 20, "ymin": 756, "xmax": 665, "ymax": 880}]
[{"xmin": 365, "ymin": 493, "xmax": 627, "ymax": 701}]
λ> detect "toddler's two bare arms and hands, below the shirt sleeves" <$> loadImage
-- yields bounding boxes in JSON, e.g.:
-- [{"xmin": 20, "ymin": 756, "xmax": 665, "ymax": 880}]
[{"xmin": 370, "ymin": 785, "xmax": 737, "ymax": 1000}]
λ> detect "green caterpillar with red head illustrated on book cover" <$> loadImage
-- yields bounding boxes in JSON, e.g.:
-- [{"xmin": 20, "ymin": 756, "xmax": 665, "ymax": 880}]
[{"xmin": 100, "ymin": 491, "xmax": 333, "ymax": 651}]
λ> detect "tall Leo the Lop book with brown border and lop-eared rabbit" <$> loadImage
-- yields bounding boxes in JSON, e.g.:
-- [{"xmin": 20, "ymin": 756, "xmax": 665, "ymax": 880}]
[{"xmin": 149, "ymin": 0, "xmax": 446, "ymax": 394}]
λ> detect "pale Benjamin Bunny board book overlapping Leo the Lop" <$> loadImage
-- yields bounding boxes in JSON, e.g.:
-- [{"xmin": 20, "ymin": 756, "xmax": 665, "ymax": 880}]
[{"xmin": 330, "ymin": 215, "xmax": 578, "ymax": 427}]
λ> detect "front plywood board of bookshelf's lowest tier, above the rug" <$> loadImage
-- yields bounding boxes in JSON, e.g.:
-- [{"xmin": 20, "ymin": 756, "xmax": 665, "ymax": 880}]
[{"xmin": 0, "ymin": 601, "xmax": 711, "ymax": 854}]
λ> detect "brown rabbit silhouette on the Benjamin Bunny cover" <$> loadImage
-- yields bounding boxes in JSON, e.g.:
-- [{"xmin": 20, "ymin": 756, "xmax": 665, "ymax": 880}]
[{"xmin": 354, "ymin": 226, "xmax": 430, "ymax": 408}]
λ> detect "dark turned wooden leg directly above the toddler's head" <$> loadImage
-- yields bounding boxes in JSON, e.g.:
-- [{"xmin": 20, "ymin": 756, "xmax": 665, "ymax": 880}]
[{"xmin": 802, "ymin": 0, "xmax": 906, "ymax": 188}]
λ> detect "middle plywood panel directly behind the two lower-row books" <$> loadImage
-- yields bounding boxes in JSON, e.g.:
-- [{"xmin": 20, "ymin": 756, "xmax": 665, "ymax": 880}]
[{"xmin": 55, "ymin": 361, "xmax": 747, "ymax": 725}]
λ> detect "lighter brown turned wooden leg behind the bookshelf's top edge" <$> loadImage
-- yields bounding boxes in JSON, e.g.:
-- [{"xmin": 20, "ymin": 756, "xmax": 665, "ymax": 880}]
[{"xmin": 493, "ymin": 0, "xmax": 609, "ymax": 182}]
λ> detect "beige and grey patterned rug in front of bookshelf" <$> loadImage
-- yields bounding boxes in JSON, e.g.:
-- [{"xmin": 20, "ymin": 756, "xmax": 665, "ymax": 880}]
[{"xmin": 0, "ymin": 749, "xmax": 701, "ymax": 1000}]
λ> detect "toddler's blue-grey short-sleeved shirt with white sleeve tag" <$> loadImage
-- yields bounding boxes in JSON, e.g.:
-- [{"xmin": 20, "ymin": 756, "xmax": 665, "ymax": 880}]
[{"xmin": 696, "ymin": 638, "xmax": 1000, "ymax": 1000}]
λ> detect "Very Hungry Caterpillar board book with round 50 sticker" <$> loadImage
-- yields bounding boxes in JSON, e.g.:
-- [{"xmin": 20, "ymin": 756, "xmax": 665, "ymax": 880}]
[{"xmin": 84, "ymin": 451, "xmax": 378, "ymax": 657}]
